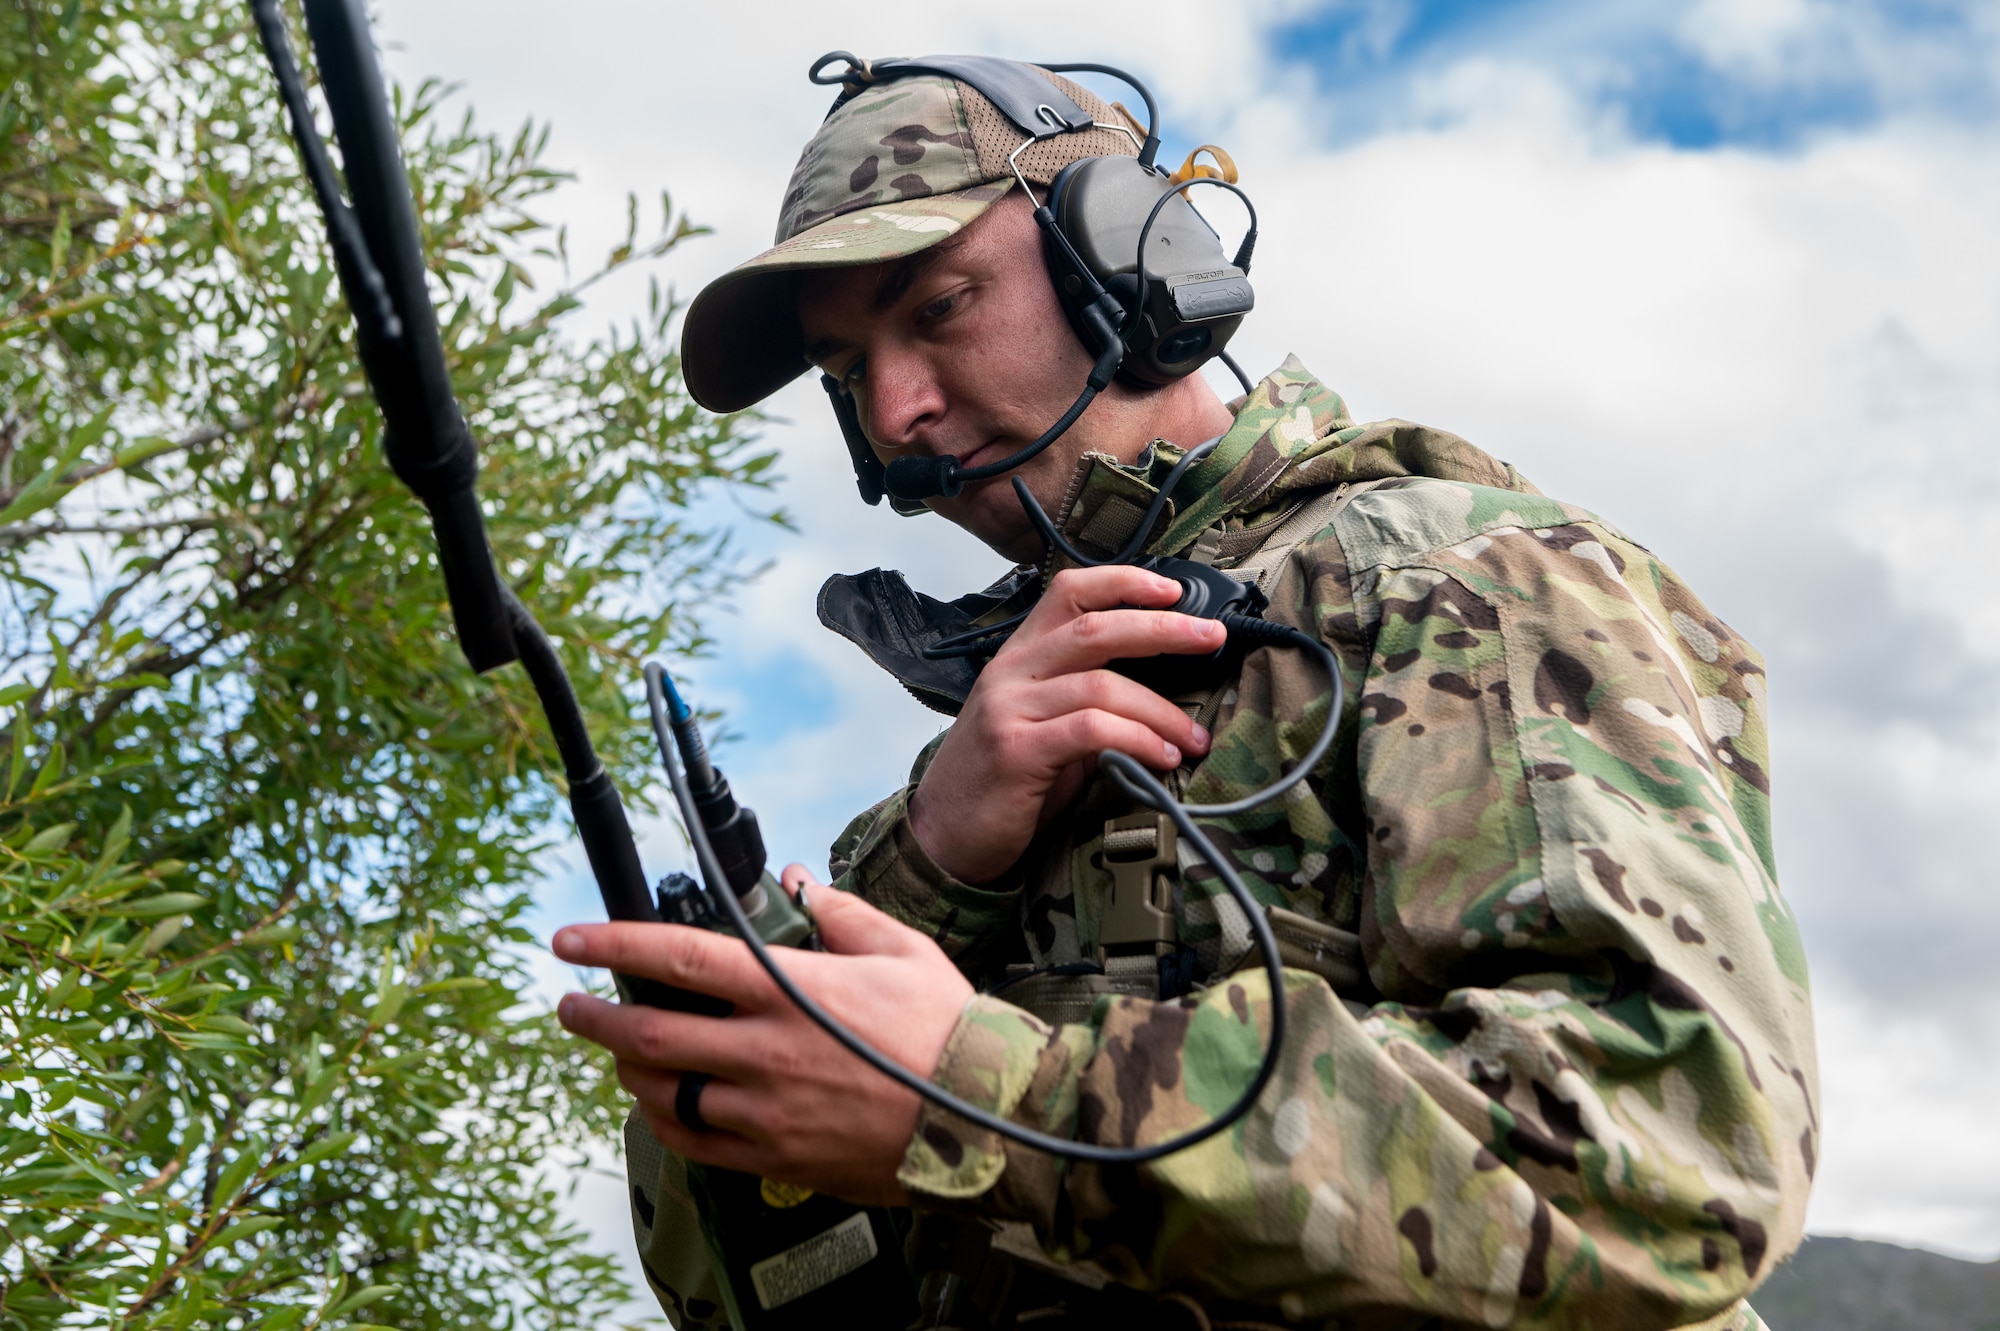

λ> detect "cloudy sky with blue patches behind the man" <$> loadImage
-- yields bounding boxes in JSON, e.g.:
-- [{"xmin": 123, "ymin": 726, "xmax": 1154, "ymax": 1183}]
[{"xmin": 378, "ymin": 0, "xmax": 2000, "ymax": 1295}]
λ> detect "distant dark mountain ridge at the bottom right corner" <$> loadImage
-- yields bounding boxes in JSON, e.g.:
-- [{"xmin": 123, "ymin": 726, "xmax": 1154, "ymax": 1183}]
[{"xmin": 1750, "ymin": 1237, "xmax": 2000, "ymax": 1331}]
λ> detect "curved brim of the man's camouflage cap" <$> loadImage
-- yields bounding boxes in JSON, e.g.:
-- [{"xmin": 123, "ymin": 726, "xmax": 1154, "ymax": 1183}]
[{"xmin": 680, "ymin": 180, "xmax": 1014, "ymax": 412}]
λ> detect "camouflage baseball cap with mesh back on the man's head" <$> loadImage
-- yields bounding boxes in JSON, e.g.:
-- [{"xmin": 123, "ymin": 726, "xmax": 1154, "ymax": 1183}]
[{"xmin": 682, "ymin": 66, "xmax": 1144, "ymax": 412}]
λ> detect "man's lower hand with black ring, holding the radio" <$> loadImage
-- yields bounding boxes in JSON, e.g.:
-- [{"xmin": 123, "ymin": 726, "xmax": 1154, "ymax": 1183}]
[{"xmin": 554, "ymin": 863, "xmax": 972, "ymax": 1205}]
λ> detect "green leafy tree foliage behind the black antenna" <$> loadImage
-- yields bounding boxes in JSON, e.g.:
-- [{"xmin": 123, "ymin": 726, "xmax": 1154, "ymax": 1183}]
[{"xmin": 0, "ymin": 0, "xmax": 770, "ymax": 1329}]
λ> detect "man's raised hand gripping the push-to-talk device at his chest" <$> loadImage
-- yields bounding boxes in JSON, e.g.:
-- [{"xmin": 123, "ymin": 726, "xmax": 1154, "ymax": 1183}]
[{"xmin": 910, "ymin": 566, "xmax": 1224, "ymax": 883}]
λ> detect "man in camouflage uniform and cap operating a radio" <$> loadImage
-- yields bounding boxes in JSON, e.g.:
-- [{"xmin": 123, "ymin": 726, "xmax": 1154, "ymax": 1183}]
[{"xmin": 558, "ymin": 54, "xmax": 1818, "ymax": 1331}]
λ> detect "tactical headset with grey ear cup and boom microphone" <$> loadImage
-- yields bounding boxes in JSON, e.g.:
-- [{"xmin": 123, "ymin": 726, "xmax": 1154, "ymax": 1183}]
[{"xmin": 808, "ymin": 50, "xmax": 1256, "ymax": 514}]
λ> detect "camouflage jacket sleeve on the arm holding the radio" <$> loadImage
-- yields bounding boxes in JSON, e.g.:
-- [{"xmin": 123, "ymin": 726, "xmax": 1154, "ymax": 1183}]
[{"xmin": 900, "ymin": 509, "xmax": 1816, "ymax": 1331}]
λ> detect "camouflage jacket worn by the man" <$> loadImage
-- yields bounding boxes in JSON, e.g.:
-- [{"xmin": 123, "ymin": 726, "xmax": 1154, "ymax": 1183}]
[{"xmin": 822, "ymin": 360, "xmax": 1818, "ymax": 1331}]
